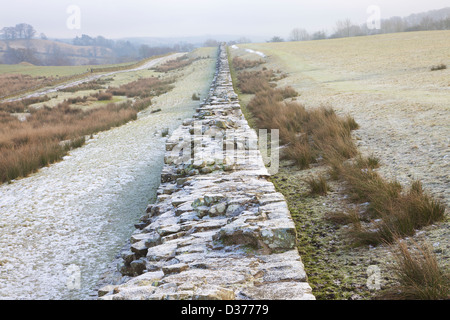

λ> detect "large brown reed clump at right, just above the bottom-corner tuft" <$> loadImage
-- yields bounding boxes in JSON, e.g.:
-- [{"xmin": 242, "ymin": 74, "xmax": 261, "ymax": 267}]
[{"xmin": 341, "ymin": 165, "xmax": 445, "ymax": 245}]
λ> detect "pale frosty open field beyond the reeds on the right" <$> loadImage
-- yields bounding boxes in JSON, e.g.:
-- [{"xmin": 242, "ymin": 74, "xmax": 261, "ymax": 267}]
[{"xmin": 236, "ymin": 31, "xmax": 450, "ymax": 208}]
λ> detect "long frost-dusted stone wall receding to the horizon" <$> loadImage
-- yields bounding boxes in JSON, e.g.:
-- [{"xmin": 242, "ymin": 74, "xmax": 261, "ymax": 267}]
[{"xmin": 99, "ymin": 47, "xmax": 314, "ymax": 300}]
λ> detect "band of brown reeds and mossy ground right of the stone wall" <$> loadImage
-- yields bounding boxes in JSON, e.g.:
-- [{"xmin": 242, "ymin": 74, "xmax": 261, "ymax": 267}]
[{"xmin": 230, "ymin": 47, "xmax": 449, "ymax": 299}]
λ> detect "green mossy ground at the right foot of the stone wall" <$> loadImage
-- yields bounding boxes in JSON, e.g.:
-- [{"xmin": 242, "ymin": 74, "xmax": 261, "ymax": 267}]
[{"xmin": 271, "ymin": 167, "xmax": 380, "ymax": 300}]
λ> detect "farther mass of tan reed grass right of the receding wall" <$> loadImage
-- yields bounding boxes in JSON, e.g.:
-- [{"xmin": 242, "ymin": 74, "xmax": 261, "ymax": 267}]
[{"xmin": 232, "ymin": 60, "xmax": 358, "ymax": 169}]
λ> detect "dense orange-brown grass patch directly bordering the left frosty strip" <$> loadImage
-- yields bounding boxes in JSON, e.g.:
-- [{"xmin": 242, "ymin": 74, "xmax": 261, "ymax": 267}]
[{"xmin": 0, "ymin": 94, "xmax": 160, "ymax": 182}]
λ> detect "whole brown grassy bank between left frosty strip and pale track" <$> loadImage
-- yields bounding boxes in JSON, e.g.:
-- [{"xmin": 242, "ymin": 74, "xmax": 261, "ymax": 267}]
[{"xmin": 0, "ymin": 72, "xmax": 174, "ymax": 182}]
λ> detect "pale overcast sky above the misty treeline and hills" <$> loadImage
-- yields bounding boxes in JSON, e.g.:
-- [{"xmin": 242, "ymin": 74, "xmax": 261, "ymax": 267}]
[{"xmin": 0, "ymin": 0, "xmax": 449, "ymax": 39}]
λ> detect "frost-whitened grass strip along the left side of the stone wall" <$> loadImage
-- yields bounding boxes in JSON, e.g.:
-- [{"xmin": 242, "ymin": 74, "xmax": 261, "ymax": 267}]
[{"xmin": 0, "ymin": 49, "xmax": 216, "ymax": 300}]
